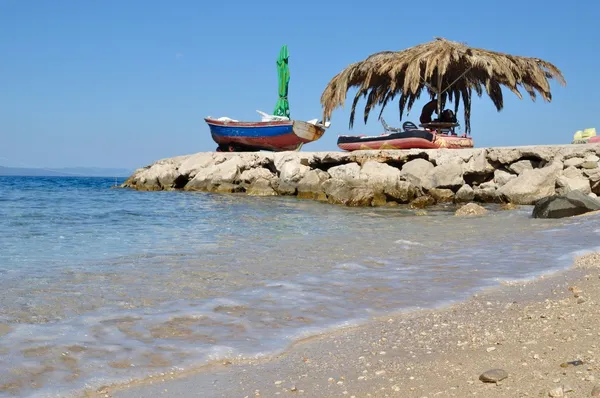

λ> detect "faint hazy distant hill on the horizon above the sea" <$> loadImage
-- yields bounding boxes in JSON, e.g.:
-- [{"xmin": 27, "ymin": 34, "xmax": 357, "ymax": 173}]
[{"xmin": 0, "ymin": 166, "xmax": 133, "ymax": 177}]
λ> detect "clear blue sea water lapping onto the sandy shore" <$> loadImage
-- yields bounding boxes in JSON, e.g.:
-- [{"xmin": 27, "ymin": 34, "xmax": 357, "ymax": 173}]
[{"xmin": 0, "ymin": 177, "xmax": 600, "ymax": 397}]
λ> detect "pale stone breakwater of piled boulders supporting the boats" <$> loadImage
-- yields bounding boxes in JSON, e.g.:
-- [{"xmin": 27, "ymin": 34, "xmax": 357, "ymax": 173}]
[{"xmin": 121, "ymin": 144, "xmax": 600, "ymax": 207}]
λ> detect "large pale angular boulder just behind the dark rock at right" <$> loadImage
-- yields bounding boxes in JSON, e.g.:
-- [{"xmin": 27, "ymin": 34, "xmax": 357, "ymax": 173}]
[{"xmin": 497, "ymin": 162, "xmax": 563, "ymax": 205}]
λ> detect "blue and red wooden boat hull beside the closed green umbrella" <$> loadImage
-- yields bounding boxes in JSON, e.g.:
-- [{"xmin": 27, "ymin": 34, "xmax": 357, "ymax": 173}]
[{"xmin": 204, "ymin": 118, "xmax": 325, "ymax": 151}]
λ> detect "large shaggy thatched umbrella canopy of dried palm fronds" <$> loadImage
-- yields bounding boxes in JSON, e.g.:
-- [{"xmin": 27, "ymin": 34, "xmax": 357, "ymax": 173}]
[{"xmin": 321, "ymin": 38, "xmax": 566, "ymax": 133}]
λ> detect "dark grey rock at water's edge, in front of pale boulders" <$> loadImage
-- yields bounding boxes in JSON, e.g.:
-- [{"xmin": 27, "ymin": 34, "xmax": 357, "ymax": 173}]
[{"xmin": 532, "ymin": 191, "xmax": 600, "ymax": 218}]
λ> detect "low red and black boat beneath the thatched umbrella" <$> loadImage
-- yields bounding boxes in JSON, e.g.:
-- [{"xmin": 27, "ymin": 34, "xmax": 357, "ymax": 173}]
[{"xmin": 337, "ymin": 130, "xmax": 473, "ymax": 151}]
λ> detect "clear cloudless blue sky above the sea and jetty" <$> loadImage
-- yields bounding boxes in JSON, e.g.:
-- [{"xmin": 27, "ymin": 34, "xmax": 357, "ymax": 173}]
[{"xmin": 0, "ymin": 0, "xmax": 600, "ymax": 168}]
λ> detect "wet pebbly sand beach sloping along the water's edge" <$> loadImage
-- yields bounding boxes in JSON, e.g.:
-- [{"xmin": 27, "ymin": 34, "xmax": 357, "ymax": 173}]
[{"xmin": 86, "ymin": 253, "xmax": 600, "ymax": 398}]
